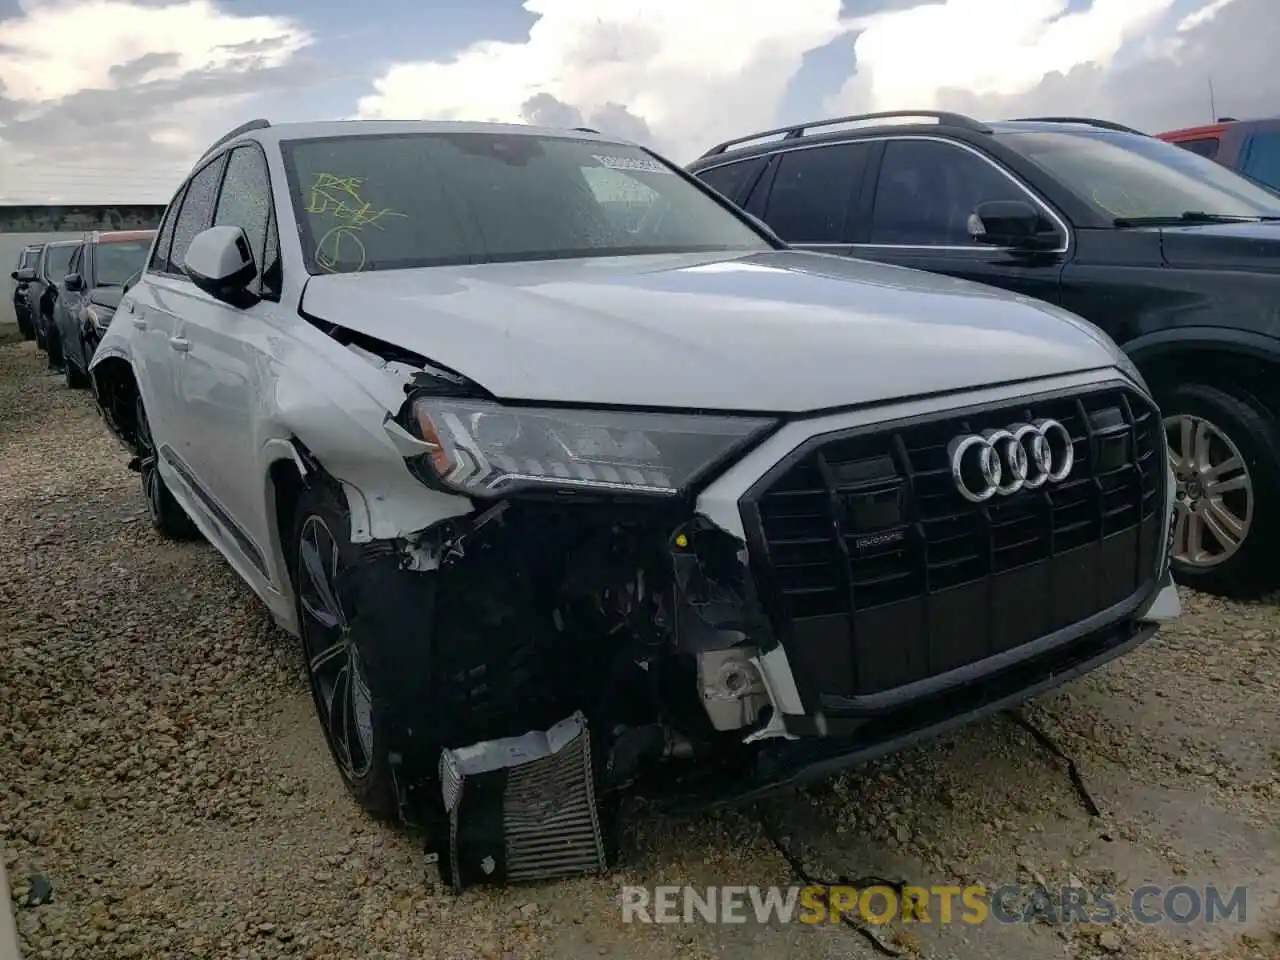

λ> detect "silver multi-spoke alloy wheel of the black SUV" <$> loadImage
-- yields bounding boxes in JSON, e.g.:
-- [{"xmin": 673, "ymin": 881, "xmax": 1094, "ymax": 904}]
[{"xmin": 1165, "ymin": 413, "xmax": 1253, "ymax": 567}]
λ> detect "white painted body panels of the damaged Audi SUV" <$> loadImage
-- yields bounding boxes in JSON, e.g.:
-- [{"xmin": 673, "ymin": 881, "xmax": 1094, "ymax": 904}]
[{"xmin": 91, "ymin": 123, "xmax": 1176, "ymax": 752}]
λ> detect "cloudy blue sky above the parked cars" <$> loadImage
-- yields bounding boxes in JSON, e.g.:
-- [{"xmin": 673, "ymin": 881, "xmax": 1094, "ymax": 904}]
[{"xmin": 0, "ymin": 0, "xmax": 1264, "ymax": 204}]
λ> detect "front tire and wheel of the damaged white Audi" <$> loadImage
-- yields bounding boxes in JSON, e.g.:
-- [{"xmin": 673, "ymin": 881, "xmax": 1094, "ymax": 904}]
[{"xmin": 289, "ymin": 480, "xmax": 399, "ymax": 820}]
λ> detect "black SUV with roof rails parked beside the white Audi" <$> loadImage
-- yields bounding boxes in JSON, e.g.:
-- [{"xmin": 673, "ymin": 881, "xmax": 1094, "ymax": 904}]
[{"xmin": 689, "ymin": 111, "xmax": 1280, "ymax": 596}]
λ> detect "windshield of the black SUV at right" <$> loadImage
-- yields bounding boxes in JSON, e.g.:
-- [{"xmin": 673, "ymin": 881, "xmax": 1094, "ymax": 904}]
[{"xmin": 998, "ymin": 132, "xmax": 1280, "ymax": 219}]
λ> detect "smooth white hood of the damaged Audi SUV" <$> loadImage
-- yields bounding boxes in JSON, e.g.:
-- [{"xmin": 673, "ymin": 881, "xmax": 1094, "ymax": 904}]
[{"xmin": 302, "ymin": 251, "xmax": 1114, "ymax": 413}]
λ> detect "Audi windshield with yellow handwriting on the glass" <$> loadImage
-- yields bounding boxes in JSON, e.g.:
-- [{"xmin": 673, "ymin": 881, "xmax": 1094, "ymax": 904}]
[{"xmin": 282, "ymin": 132, "xmax": 771, "ymax": 274}]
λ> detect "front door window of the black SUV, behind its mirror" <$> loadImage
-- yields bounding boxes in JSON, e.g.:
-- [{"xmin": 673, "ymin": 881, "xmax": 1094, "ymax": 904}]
[{"xmin": 869, "ymin": 140, "xmax": 1029, "ymax": 247}]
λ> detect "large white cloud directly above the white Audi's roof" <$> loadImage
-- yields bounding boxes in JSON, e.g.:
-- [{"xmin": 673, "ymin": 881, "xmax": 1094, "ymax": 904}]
[{"xmin": 360, "ymin": 0, "xmax": 844, "ymax": 159}]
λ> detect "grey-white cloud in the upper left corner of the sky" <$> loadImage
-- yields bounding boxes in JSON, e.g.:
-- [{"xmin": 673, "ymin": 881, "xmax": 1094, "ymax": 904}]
[{"xmin": 0, "ymin": 0, "xmax": 320, "ymax": 202}]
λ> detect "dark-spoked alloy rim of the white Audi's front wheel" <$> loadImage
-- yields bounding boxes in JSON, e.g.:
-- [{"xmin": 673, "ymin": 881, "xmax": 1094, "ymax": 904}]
[{"xmin": 297, "ymin": 516, "xmax": 374, "ymax": 780}]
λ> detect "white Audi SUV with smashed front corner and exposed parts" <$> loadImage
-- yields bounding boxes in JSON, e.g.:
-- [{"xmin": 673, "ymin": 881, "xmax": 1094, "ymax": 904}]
[{"xmin": 90, "ymin": 122, "xmax": 1178, "ymax": 878}]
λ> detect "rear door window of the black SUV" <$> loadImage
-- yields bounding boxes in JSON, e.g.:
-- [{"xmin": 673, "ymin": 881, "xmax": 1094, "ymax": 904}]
[{"xmin": 763, "ymin": 143, "xmax": 872, "ymax": 243}]
